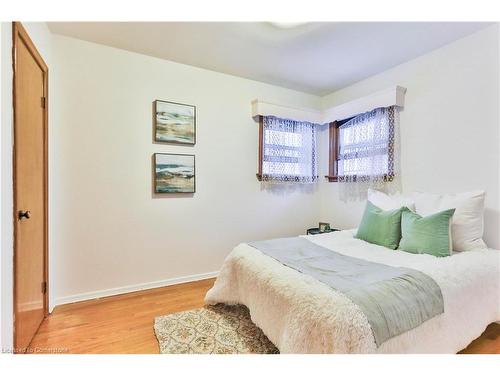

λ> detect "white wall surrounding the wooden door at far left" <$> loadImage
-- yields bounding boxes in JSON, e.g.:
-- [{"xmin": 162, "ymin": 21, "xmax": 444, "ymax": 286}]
[{"xmin": 0, "ymin": 22, "xmax": 52, "ymax": 349}]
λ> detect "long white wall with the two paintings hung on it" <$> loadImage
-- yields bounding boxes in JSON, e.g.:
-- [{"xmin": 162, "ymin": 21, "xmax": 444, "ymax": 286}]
[{"xmin": 50, "ymin": 36, "xmax": 320, "ymax": 303}]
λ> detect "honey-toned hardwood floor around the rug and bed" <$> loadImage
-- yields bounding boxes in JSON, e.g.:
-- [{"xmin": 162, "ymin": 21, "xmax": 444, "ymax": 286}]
[{"xmin": 30, "ymin": 279, "xmax": 500, "ymax": 353}]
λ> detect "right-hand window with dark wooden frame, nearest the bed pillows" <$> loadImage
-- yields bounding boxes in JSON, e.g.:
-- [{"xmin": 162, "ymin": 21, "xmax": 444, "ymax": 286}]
[{"xmin": 326, "ymin": 107, "xmax": 396, "ymax": 182}]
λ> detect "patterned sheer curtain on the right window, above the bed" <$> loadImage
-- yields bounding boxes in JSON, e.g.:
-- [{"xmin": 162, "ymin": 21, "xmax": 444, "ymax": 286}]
[{"xmin": 338, "ymin": 106, "xmax": 401, "ymax": 201}]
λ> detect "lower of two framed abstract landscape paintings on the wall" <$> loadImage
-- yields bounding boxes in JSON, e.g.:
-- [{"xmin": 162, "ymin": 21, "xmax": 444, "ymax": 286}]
[{"xmin": 154, "ymin": 154, "xmax": 195, "ymax": 193}]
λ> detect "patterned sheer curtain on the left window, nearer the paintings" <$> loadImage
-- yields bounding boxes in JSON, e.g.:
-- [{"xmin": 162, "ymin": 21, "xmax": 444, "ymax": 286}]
[{"xmin": 262, "ymin": 116, "xmax": 318, "ymax": 183}]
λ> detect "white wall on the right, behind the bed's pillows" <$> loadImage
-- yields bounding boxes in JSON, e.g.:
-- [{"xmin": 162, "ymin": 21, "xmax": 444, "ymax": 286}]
[{"xmin": 320, "ymin": 25, "xmax": 500, "ymax": 248}]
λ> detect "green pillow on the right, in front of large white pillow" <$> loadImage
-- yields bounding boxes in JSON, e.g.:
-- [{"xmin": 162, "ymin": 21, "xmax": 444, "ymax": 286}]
[{"xmin": 398, "ymin": 208, "xmax": 455, "ymax": 257}]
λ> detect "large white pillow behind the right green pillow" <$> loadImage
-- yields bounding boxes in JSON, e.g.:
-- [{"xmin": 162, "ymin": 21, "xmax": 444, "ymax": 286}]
[{"xmin": 413, "ymin": 191, "xmax": 487, "ymax": 251}]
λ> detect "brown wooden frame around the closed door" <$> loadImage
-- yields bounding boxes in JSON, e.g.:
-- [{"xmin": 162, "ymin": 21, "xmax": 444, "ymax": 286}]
[{"xmin": 12, "ymin": 22, "xmax": 49, "ymax": 348}]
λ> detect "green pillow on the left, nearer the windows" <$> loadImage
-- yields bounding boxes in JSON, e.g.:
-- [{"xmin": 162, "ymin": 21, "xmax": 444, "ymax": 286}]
[{"xmin": 354, "ymin": 201, "xmax": 406, "ymax": 250}]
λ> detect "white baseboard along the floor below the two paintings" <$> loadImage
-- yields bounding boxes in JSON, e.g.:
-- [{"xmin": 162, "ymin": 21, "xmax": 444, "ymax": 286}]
[{"xmin": 50, "ymin": 271, "xmax": 219, "ymax": 312}]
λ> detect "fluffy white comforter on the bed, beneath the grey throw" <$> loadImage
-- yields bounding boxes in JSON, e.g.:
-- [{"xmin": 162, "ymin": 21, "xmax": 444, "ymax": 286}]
[{"xmin": 205, "ymin": 231, "xmax": 500, "ymax": 353}]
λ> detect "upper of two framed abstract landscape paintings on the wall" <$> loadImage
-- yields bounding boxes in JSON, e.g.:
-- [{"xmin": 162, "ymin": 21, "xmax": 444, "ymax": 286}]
[{"xmin": 154, "ymin": 100, "xmax": 196, "ymax": 145}]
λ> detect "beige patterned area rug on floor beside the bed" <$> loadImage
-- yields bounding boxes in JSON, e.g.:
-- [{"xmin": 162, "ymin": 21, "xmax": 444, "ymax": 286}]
[{"xmin": 154, "ymin": 304, "xmax": 279, "ymax": 354}]
